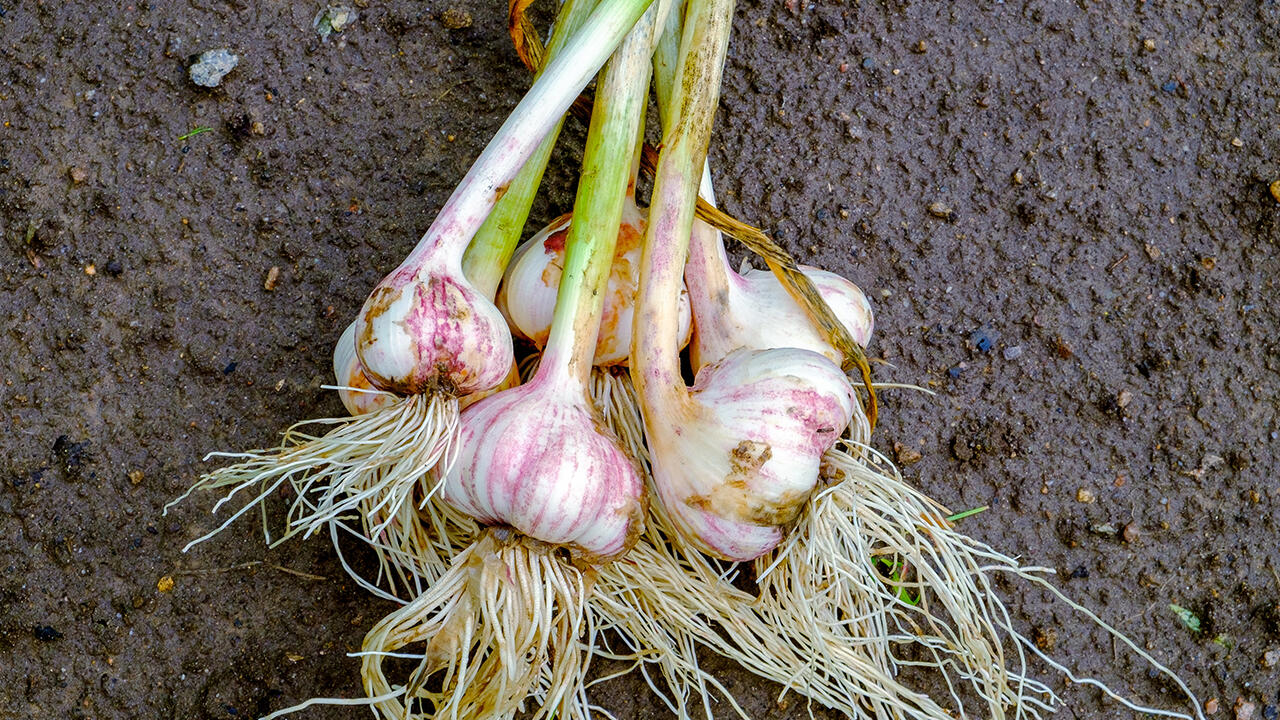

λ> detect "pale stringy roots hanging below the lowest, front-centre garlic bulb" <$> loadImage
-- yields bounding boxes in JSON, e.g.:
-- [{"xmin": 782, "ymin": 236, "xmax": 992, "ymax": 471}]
[{"xmin": 361, "ymin": 529, "xmax": 596, "ymax": 720}]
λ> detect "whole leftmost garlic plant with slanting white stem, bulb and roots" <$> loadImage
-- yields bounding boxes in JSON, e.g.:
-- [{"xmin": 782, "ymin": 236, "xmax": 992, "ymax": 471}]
[{"xmin": 170, "ymin": 0, "xmax": 652, "ymax": 556}]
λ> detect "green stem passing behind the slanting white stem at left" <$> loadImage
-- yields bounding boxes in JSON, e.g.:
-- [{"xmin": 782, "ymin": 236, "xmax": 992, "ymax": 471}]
[{"xmin": 462, "ymin": 0, "xmax": 595, "ymax": 300}]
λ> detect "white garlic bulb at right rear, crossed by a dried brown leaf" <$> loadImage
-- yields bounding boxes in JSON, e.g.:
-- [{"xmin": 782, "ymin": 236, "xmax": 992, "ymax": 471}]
[{"xmin": 686, "ymin": 260, "xmax": 876, "ymax": 370}]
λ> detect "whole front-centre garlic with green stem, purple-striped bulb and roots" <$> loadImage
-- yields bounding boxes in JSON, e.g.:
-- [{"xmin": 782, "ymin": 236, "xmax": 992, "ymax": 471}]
[{"xmin": 362, "ymin": 8, "xmax": 658, "ymax": 719}]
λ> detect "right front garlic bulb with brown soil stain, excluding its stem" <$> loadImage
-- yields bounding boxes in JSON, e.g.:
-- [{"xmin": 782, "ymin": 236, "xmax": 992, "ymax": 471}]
[{"xmin": 645, "ymin": 348, "xmax": 855, "ymax": 561}]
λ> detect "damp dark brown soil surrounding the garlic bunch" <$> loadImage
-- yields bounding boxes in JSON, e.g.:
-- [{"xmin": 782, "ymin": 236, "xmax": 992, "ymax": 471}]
[{"xmin": 0, "ymin": 0, "xmax": 1280, "ymax": 719}]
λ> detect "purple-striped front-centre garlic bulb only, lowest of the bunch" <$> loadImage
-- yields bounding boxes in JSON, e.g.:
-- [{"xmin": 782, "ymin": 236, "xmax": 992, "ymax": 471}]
[{"xmin": 440, "ymin": 377, "xmax": 645, "ymax": 562}]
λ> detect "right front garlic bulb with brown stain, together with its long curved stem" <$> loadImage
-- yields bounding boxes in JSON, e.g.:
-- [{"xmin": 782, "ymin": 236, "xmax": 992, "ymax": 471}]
[{"xmin": 631, "ymin": 0, "xmax": 854, "ymax": 560}]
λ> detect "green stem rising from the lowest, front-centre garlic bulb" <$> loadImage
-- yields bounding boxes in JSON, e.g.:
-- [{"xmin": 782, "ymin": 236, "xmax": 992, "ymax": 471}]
[{"xmin": 538, "ymin": 8, "xmax": 658, "ymax": 392}]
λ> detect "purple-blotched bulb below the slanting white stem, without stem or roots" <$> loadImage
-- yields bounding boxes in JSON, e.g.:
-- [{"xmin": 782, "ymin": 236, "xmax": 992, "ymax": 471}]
[{"xmin": 356, "ymin": 259, "xmax": 515, "ymax": 396}]
